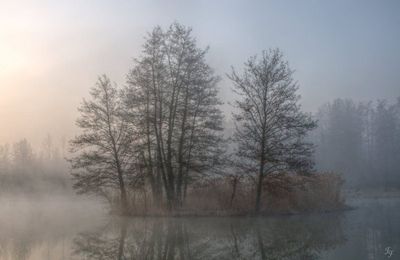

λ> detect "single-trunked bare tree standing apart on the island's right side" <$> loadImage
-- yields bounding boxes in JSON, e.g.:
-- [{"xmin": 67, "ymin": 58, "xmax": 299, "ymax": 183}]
[{"xmin": 228, "ymin": 49, "xmax": 316, "ymax": 213}]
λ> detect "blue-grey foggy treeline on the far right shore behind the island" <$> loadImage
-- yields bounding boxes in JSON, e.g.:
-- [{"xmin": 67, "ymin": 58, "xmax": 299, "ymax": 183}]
[{"xmin": 313, "ymin": 97, "xmax": 400, "ymax": 189}]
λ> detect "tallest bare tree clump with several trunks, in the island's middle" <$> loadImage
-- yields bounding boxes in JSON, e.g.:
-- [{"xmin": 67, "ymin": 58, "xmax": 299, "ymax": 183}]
[{"xmin": 125, "ymin": 23, "xmax": 222, "ymax": 208}]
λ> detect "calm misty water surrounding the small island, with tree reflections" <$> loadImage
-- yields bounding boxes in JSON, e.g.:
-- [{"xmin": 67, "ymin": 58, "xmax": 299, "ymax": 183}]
[{"xmin": 0, "ymin": 197, "xmax": 400, "ymax": 260}]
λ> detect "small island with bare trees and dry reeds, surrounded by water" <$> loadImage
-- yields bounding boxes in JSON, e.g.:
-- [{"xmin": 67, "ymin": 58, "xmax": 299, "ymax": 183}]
[{"xmin": 69, "ymin": 23, "xmax": 344, "ymax": 216}]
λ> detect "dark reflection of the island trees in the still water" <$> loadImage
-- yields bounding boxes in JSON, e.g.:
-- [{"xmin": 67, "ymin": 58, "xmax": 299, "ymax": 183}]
[{"xmin": 74, "ymin": 214, "xmax": 345, "ymax": 260}]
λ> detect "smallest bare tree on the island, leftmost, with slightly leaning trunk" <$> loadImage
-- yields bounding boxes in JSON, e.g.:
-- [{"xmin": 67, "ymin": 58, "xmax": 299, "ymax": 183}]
[{"xmin": 70, "ymin": 76, "xmax": 140, "ymax": 213}]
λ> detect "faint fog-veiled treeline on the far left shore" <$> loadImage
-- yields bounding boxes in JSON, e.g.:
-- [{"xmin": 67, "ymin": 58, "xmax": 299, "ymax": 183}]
[{"xmin": 0, "ymin": 136, "xmax": 71, "ymax": 194}]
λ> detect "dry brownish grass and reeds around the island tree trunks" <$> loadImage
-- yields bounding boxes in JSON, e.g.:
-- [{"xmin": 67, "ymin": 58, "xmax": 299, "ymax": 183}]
[{"xmin": 108, "ymin": 173, "xmax": 344, "ymax": 216}]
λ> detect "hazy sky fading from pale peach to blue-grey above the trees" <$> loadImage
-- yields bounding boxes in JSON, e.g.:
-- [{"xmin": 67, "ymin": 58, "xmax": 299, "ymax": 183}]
[{"xmin": 0, "ymin": 0, "xmax": 400, "ymax": 145}]
